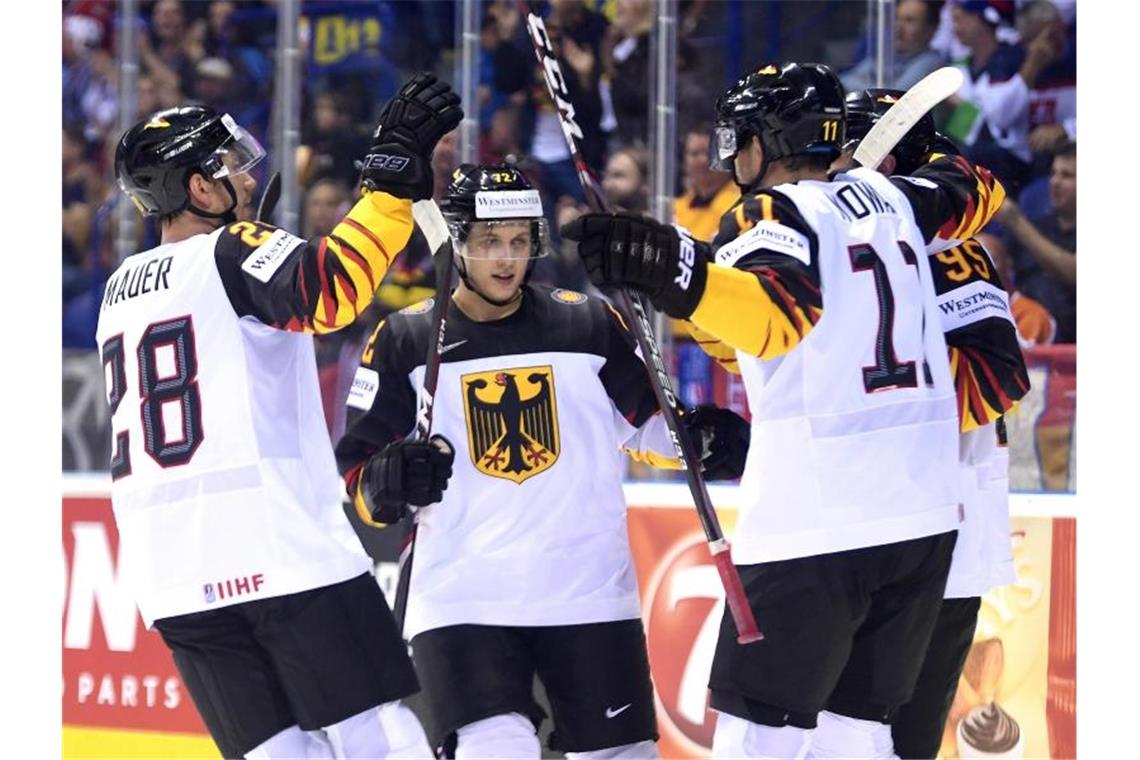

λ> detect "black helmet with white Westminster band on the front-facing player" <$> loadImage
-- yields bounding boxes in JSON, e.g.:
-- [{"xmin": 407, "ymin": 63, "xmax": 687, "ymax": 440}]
[{"xmin": 439, "ymin": 164, "xmax": 547, "ymax": 259}]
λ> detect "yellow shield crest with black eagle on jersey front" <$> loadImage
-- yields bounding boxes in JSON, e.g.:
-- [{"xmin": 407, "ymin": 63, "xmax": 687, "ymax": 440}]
[{"xmin": 461, "ymin": 365, "xmax": 559, "ymax": 483}]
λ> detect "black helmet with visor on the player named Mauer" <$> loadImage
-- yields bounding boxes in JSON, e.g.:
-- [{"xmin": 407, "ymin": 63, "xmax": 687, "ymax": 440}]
[{"xmin": 115, "ymin": 106, "xmax": 266, "ymax": 221}]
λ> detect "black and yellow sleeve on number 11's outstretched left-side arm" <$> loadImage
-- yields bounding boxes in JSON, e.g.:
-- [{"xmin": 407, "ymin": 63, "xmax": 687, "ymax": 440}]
[{"xmin": 691, "ymin": 190, "xmax": 823, "ymax": 363}]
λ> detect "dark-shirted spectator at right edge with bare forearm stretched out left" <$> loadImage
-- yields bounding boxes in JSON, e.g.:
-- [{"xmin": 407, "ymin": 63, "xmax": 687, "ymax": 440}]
[{"xmin": 998, "ymin": 144, "xmax": 1076, "ymax": 343}]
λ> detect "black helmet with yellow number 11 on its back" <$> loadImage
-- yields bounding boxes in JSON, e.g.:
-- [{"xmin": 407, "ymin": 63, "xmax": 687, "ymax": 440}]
[{"xmin": 709, "ymin": 63, "xmax": 846, "ymax": 177}]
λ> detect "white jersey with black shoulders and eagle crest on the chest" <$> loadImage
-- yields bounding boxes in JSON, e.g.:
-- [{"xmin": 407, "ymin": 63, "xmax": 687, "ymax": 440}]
[{"xmin": 336, "ymin": 286, "xmax": 671, "ymax": 637}]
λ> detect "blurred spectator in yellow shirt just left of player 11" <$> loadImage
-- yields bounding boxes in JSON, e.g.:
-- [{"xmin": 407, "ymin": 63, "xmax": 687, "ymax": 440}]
[{"xmin": 673, "ymin": 123, "xmax": 740, "ymax": 243}]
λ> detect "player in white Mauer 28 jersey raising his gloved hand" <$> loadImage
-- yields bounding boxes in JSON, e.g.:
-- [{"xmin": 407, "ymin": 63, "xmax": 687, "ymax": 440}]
[{"xmin": 97, "ymin": 75, "xmax": 463, "ymax": 758}]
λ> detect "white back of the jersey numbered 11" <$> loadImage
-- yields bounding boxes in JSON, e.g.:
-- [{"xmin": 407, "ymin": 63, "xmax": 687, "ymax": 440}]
[{"xmin": 716, "ymin": 169, "xmax": 960, "ymax": 564}]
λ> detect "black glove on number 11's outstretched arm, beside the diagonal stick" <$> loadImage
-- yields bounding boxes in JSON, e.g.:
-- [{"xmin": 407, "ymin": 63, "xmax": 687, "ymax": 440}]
[{"xmin": 561, "ymin": 214, "xmax": 708, "ymax": 319}]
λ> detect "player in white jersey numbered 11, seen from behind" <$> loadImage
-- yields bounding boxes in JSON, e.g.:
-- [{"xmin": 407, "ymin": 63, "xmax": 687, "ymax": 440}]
[{"xmin": 562, "ymin": 64, "xmax": 1003, "ymax": 758}]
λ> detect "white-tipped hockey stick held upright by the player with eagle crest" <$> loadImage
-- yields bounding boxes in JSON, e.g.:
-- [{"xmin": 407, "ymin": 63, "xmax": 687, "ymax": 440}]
[{"xmin": 394, "ymin": 201, "xmax": 454, "ymax": 636}]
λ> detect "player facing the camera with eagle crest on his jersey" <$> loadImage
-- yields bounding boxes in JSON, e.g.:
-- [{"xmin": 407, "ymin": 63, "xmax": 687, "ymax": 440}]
[{"xmin": 336, "ymin": 164, "xmax": 748, "ymax": 758}]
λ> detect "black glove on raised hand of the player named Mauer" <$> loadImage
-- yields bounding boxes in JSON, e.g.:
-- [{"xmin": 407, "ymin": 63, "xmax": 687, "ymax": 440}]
[{"xmin": 360, "ymin": 72, "xmax": 463, "ymax": 201}]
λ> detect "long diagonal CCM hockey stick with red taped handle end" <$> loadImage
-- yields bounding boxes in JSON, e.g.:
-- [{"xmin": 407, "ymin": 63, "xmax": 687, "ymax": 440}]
[{"xmin": 520, "ymin": 5, "xmax": 764, "ymax": 644}]
